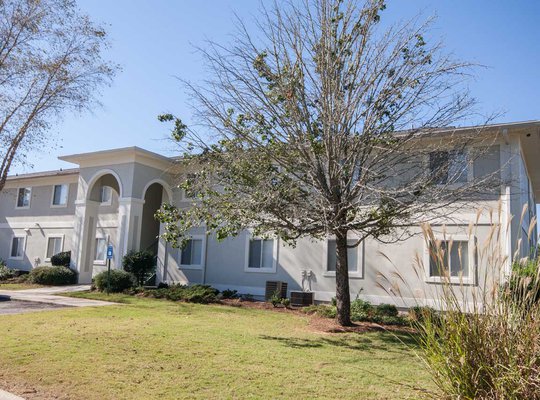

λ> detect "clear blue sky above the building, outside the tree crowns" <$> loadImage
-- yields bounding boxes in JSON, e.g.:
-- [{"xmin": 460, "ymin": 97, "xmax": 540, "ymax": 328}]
[{"xmin": 12, "ymin": 0, "xmax": 540, "ymax": 173}]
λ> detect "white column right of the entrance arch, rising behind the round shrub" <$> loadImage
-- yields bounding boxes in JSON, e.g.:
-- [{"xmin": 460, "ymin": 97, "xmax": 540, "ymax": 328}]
[{"xmin": 116, "ymin": 197, "xmax": 144, "ymax": 266}]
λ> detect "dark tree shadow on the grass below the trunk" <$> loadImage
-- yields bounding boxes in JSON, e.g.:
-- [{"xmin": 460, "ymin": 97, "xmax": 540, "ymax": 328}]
[{"xmin": 259, "ymin": 332, "xmax": 418, "ymax": 353}]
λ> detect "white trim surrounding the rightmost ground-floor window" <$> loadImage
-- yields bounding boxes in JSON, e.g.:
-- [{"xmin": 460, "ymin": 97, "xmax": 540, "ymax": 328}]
[{"xmin": 424, "ymin": 233, "xmax": 477, "ymax": 285}]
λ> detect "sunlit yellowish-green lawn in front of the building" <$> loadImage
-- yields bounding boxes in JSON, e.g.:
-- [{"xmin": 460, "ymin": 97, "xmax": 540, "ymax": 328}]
[{"xmin": 0, "ymin": 293, "xmax": 429, "ymax": 399}]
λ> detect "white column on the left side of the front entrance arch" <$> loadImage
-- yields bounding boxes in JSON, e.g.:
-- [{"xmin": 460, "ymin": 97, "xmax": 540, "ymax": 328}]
[{"xmin": 71, "ymin": 200, "xmax": 99, "ymax": 283}]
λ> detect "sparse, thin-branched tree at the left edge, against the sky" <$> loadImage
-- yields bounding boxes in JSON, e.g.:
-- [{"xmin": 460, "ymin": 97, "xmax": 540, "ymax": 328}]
[{"xmin": 0, "ymin": 0, "xmax": 117, "ymax": 190}]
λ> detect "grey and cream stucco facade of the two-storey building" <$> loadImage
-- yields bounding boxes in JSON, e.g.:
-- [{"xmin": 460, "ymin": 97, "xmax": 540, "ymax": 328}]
[{"xmin": 0, "ymin": 122, "xmax": 540, "ymax": 305}]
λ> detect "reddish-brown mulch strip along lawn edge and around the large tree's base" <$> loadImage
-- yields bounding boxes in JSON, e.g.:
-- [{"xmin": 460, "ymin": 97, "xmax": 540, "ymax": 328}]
[{"xmin": 217, "ymin": 299, "xmax": 415, "ymax": 334}]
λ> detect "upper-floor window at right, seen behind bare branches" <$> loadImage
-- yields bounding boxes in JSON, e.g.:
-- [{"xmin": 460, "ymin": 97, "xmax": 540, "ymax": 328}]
[{"xmin": 429, "ymin": 150, "xmax": 468, "ymax": 185}]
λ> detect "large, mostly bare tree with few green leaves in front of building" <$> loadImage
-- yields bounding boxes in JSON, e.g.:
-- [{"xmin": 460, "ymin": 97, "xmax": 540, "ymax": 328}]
[{"xmin": 158, "ymin": 0, "xmax": 496, "ymax": 325}]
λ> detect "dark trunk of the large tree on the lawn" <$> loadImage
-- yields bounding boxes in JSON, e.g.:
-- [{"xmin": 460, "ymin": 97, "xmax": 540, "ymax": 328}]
[{"xmin": 336, "ymin": 231, "xmax": 352, "ymax": 326}]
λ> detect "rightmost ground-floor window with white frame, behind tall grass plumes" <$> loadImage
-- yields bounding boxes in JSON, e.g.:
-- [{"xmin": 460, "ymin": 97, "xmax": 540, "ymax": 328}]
[{"xmin": 425, "ymin": 236, "xmax": 475, "ymax": 283}]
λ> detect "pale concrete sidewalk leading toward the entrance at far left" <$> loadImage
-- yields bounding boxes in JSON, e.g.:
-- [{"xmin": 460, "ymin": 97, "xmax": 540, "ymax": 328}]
[{"xmin": 0, "ymin": 285, "xmax": 118, "ymax": 307}]
